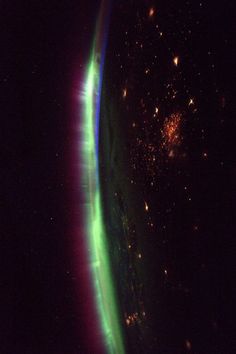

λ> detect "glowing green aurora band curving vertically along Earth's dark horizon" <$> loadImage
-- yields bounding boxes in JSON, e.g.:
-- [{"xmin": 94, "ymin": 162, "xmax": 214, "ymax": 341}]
[{"xmin": 82, "ymin": 4, "xmax": 125, "ymax": 354}]
